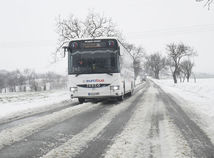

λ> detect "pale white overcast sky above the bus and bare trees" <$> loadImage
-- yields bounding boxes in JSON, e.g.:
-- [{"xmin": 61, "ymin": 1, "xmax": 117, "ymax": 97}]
[{"xmin": 0, "ymin": 0, "xmax": 214, "ymax": 74}]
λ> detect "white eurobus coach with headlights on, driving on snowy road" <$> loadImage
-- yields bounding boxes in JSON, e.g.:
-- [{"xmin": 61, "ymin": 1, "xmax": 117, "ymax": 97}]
[{"xmin": 65, "ymin": 38, "xmax": 134, "ymax": 103}]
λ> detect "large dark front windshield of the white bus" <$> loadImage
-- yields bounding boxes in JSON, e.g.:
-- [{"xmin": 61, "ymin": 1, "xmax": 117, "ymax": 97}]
[{"xmin": 69, "ymin": 50, "xmax": 119, "ymax": 74}]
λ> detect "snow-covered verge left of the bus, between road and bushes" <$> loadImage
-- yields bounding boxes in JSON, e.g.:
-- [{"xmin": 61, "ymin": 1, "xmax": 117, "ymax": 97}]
[{"xmin": 0, "ymin": 89, "xmax": 70, "ymax": 120}]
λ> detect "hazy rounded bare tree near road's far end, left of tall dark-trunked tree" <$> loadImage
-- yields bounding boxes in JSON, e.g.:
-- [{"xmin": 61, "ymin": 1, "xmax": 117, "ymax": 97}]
[{"xmin": 145, "ymin": 53, "xmax": 167, "ymax": 79}]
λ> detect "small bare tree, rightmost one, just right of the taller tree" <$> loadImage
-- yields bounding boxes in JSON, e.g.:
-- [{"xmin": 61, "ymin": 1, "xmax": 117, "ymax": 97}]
[{"xmin": 180, "ymin": 60, "xmax": 194, "ymax": 82}]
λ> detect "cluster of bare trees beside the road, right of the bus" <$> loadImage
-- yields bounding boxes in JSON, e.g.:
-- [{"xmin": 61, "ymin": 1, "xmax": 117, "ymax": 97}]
[{"xmin": 145, "ymin": 43, "xmax": 197, "ymax": 83}]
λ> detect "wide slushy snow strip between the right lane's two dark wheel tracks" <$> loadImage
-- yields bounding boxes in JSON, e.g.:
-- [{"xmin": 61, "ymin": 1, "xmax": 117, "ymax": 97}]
[{"xmin": 103, "ymin": 81, "xmax": 192, "ymax": 158}]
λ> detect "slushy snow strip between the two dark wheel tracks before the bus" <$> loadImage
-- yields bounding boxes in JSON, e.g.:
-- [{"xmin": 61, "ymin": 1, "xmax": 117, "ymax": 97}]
[{"xmin": 0, "ymin": 100, "xmax": 100, "ymax": 149}]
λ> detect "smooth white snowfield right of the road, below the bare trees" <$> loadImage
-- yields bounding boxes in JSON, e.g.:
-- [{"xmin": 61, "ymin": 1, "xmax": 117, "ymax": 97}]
[{"xmin": 152, "ymin": 79, "xmax": 214, "ymax": 143}]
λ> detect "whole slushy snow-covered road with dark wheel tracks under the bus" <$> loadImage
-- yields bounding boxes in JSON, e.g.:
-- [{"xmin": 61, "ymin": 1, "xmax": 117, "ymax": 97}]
[{"xmin": 0, "ymin": 81, "xmax": 214, "ymax": 158}]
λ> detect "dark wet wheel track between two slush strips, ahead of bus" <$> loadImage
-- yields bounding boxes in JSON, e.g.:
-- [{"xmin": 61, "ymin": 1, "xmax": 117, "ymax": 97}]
[{"xmin": 0, "ymin": 104, "xmax": 110, "ymax": 158}]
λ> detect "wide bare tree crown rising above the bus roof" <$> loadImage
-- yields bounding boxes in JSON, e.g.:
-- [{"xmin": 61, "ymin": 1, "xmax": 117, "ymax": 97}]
[{"xmin": 54, "ymin": 12, "xmax": 122, "ymax": 57}]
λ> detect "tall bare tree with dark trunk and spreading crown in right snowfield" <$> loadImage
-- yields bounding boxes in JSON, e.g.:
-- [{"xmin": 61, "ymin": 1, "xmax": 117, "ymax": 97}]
[{"xmin": 166, "ymin": 43, "xmax": 196, "ymax": 83}]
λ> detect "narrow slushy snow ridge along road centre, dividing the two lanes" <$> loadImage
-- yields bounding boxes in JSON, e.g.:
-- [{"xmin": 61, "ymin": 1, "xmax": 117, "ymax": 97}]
[{"xmin": 43, "ymin": 87, "xmax": 146, "ymax": 158}]
